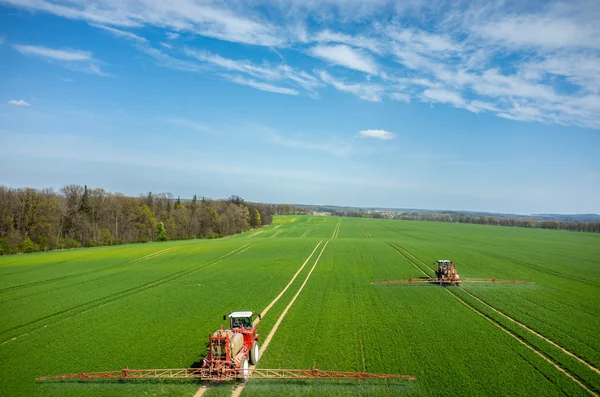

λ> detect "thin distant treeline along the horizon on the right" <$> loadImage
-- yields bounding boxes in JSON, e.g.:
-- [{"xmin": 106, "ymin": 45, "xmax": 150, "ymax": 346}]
[{"xmin": 333, "ymin": 211, "xmax": 600, "ymax": 233}]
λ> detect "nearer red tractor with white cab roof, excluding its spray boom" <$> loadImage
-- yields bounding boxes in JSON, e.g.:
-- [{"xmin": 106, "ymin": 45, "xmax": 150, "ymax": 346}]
[{"xmin": 202, "ymin": 312, "xmax": 260, "ymax": 382}]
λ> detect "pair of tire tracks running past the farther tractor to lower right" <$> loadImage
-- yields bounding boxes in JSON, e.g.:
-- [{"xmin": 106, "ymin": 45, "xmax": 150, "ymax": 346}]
[{"xmin": 395, "ymin": 243, "xmax": 600, "ymax": 396}]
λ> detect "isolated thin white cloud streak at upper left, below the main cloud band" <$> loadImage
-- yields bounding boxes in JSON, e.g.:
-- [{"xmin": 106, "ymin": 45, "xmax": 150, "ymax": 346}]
[{"xmin": 13, "ymin": 44, "xmax": 108, "ymax": 76}]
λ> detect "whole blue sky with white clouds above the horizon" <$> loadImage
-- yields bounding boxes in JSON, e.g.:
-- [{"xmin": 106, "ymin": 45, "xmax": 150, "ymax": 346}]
[{"xmin": 0, "ymin": 0, "xmax": 600, "ymax": 213}]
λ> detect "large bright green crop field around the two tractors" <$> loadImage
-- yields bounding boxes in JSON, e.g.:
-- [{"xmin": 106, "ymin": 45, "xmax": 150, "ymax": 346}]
[{"xmin": 0, "ymin": 215, "xmax": 600, "ymax": 396}]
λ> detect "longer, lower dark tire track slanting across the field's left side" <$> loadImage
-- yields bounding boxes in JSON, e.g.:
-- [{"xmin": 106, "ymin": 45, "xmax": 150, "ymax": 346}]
[{"xmin": 0, "ymin": 243, "xmax": 253, "ymax": 346}]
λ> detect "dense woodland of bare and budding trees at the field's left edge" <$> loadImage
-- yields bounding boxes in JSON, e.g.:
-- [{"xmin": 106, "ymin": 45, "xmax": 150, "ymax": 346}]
[{"xmin": 0, "ymin": 185, "xmax": 278, "ymax": 255}]
